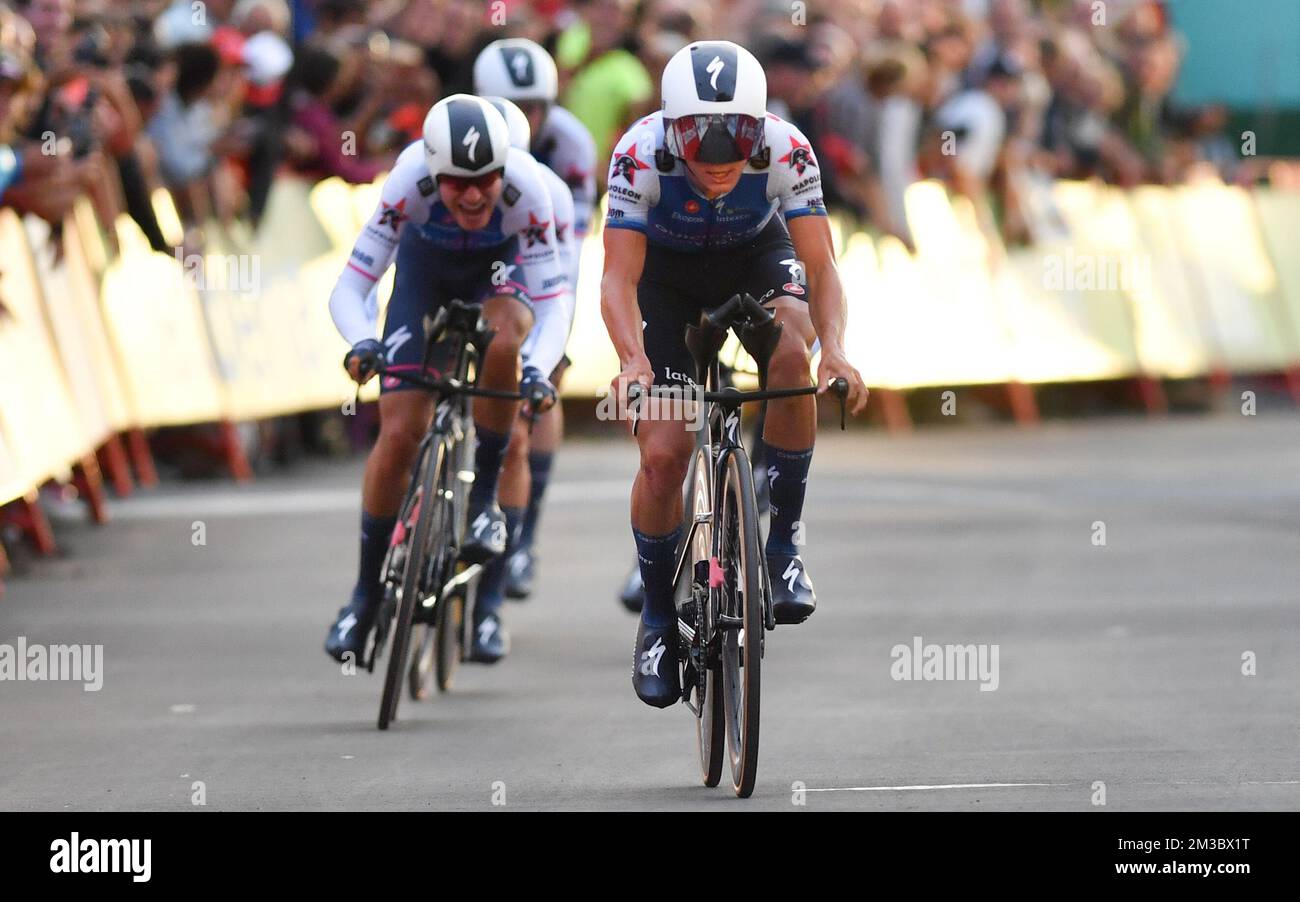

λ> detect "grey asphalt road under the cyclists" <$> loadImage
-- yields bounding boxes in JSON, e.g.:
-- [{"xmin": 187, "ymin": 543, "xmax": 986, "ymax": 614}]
[{"xmin": 0, "ymin": 413, "xmax": 1300, "ymax": 810}]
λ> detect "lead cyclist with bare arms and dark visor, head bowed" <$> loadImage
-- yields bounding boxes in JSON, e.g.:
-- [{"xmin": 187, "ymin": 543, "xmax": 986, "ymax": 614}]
[{"xmin": 601, "ymin": 40, "xmax": 867, "ymax": 707}]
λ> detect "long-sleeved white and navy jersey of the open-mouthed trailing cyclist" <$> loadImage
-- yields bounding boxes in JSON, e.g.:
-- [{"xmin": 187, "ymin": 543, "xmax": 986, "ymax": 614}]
[{"xmin": 329, "ymin": 142, "xmax": 573, "ymax": 373}]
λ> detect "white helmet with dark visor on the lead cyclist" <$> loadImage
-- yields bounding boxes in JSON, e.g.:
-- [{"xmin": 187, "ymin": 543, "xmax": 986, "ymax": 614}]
[{"xmin": 660, "ymin": 40, "xmax": 767, "ymax": 162}]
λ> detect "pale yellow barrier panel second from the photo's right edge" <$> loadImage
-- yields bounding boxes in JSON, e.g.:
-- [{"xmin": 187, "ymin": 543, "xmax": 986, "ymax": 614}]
[{"xmin": 1170, "ymin": 185, "xmax": 1295, "ymax": 372}]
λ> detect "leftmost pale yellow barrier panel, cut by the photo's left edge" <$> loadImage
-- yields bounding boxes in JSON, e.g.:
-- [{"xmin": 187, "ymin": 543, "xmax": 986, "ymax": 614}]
[{"xmin": 0, "ymin": 209, "xmax": 94, "ymax": 490}]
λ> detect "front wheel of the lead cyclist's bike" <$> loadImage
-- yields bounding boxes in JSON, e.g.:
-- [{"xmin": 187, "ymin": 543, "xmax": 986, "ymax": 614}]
[{"xmin": 715, "ymin": 448, "xmax": 763, "ymax": 798}]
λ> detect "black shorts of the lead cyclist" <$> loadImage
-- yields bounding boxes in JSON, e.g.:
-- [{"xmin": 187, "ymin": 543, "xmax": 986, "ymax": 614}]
[{"xmin": 637, "ymin": 219, "xmax": 807, "ymax": 385}]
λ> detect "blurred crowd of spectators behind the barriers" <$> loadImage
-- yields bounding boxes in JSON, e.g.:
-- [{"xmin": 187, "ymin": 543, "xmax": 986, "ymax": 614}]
[{"xmin": 0, "ymin": 0, "xmax": 1279, "ymax": 265}]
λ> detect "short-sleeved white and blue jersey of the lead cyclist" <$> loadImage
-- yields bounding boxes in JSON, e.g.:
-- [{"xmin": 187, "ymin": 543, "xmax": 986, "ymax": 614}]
[{"xmin": 605, "ymin": 112, "xmax": 826, "ymax": 251}]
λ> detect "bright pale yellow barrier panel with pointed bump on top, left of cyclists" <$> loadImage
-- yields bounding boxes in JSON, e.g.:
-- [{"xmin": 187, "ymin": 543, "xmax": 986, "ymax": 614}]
[{"xmin": 100, "ymin": 214, "xmax": 225, "ymax": 426}]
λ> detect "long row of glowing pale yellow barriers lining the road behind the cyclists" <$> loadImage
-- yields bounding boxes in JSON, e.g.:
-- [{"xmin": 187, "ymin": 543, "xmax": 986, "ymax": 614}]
[{"xmin": 0, "ymin": 178, "xmax": 1300, "ymax": 543}]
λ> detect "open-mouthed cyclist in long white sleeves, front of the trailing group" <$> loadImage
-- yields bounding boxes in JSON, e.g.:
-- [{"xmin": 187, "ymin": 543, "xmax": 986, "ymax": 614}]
[{"xmin": 325, "ymin": 94, "xmax": 572, "ymax": 662}]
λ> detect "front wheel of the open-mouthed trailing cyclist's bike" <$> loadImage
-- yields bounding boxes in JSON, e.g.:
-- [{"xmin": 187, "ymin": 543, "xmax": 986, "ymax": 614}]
[{"xmin": 378, "ymin": 441, "xmax": 450, "ymax": 729}]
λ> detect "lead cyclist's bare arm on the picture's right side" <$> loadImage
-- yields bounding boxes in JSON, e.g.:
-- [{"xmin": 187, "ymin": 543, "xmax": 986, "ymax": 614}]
[{"xmin": 787, "ymin": 216, "xmax": 867, "ymax": 413}]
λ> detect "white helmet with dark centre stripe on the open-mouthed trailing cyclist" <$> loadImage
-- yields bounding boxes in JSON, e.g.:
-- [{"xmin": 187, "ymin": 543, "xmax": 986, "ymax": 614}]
[{"xmin": 424, "ymin": 94, "xmax": 510, "ymax": 179}]
